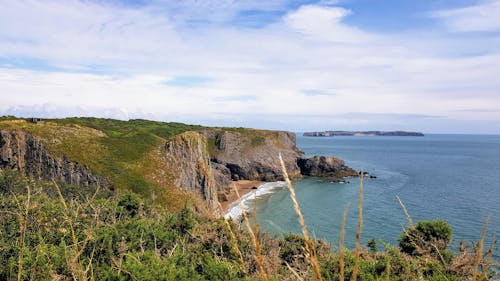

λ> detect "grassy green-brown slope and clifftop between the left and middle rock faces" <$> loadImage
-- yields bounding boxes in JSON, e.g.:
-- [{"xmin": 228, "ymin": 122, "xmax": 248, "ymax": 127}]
[{"xmin": 0, "ymin": 118, "xmax": 206, "ymax": 208}]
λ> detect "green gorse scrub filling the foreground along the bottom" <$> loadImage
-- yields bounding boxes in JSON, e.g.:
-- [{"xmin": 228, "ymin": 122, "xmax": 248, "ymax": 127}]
[{"xmin": 0, "ymin": 171, "xmax": 493, "ymax": 281}]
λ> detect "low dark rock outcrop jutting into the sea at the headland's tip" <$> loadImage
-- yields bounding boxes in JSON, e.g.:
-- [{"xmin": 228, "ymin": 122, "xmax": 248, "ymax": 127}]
[{"xmin": 297, "ymin": 156, "xmax": 358, "ymax": 181}]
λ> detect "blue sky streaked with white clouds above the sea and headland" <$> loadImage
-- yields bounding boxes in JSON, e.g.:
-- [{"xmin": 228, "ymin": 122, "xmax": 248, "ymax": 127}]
[{"xmin": 0, "ymin": 0, "xmax": 500, "ymax": 134}]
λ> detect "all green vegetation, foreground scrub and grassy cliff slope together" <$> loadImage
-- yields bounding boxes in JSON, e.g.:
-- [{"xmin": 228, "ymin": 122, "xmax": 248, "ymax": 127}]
[{"xmin": 0, "ymin": 117, "xmax": 494, "ymax": 281}]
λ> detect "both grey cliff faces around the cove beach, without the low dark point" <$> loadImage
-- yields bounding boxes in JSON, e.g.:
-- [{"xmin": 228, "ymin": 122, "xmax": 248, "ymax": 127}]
[{"xmin": 165, "ymin": 129, "xmax": 302, "ymax": 207}]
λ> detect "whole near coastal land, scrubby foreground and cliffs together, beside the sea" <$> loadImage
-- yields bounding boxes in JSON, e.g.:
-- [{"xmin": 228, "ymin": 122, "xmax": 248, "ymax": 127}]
[{"xmin": 0, "ymin": 115, "xmax": 494, "ymax": 280}]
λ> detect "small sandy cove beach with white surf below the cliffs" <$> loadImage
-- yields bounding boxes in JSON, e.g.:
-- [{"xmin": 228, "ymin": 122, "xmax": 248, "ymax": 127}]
[{"xmin": 221, "ymin": 180, "xmax": 286, "ymax": 219}]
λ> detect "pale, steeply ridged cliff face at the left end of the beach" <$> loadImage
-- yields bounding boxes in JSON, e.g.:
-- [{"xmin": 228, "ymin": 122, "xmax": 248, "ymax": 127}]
[{"xmin": 165, "ymin": 132, "xmax": 219, "ymax": 207}]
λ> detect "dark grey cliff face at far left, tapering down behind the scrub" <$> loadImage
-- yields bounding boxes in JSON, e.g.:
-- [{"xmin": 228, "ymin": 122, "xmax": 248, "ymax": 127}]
[{"xmin": 0, "ymin": 130, "xmax": 111, "ymax": 188}]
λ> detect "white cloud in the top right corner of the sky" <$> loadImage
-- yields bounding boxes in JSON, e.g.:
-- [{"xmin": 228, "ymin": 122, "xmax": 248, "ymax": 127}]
[{"xmin": 431, "ymin": 0, "xmax": 500, "ymax": 32}]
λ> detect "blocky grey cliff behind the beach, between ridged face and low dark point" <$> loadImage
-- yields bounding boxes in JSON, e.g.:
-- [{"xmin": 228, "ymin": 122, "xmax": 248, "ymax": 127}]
[{"xmin": 204, "ymin": 130, "xmax": 302, "ymax": 181}]
